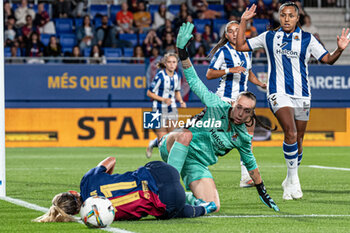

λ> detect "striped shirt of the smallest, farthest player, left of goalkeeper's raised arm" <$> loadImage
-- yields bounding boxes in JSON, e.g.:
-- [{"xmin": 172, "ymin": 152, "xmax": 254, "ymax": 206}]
[{"xmin": 149, "ymin": 69, "xmax": 181, "ymax": 113}]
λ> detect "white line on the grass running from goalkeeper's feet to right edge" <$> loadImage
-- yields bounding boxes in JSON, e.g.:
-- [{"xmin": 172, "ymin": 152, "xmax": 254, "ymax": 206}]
[{"xmin": 203, "ymin": 214, "xmax": 350, "ymax": 218}]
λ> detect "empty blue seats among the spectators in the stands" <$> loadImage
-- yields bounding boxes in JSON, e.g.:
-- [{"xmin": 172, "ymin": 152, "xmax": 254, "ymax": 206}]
[{"xmin": 6, "ymin": 0, "xmax": 282, "ymax": 62}]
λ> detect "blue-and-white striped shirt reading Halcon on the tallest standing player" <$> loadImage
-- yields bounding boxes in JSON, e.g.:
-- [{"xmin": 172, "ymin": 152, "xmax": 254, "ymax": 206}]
[{"xmin": 247, "ymin": 27, "xmax": 328, "ymax": 99}]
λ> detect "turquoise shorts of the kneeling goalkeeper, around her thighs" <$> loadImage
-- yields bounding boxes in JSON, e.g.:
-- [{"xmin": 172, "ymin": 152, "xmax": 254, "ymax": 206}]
[{"xmin": 159, "ymin": 134, "xmax": 213, "ymax": 190}]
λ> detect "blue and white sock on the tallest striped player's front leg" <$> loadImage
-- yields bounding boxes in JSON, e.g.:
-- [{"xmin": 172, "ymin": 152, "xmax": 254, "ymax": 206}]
[{"xmin": 283, "ymin": 142, "xmax": 298, "ymax": 178}]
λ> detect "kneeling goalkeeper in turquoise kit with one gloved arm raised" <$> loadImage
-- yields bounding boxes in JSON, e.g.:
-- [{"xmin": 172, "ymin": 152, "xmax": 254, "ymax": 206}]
[{"xmin": 159, "ymin": 23, "xmax": 279, "ymax": 211}]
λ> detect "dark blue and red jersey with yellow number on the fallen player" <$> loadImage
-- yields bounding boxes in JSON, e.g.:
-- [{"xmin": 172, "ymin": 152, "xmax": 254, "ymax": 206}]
[{"xmin": 80, "ymin": 166, "xmax": 166, "ymax": 220}]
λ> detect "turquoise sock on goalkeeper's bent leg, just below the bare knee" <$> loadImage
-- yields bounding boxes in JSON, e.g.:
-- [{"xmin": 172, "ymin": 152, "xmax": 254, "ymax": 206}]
[{"xmin": 168, "ymin": 141, "xmax": 188, "ymax": 173}]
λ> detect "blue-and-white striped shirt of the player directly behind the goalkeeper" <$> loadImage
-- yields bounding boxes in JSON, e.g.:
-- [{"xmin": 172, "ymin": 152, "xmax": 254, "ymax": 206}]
[{"xmin": 209, "ymin": 42, "xmax": 252, "ymax": 100}]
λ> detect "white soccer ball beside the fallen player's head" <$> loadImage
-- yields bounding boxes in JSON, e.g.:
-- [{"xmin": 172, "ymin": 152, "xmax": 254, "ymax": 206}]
[{"xmin": 80, "ymin": 196, "xmax": 115, "ymax": 228}]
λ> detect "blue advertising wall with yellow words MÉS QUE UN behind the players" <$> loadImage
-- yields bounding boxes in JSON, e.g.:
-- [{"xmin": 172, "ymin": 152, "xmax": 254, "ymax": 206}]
[{"xmin": 5, "ymin": 64, "xmax": 350, "ymax": 108}]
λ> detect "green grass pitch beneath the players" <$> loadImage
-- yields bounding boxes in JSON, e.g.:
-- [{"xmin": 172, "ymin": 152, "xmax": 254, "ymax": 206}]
[{"xmin": 0, "ymin": 147, "xmax": 350, "ymax": 233}]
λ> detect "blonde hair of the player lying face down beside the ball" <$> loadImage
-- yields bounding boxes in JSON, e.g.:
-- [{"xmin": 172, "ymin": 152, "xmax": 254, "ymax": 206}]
[{"xmin": 32, "ymin": 192, "xmax": 81, "ymax": 222}]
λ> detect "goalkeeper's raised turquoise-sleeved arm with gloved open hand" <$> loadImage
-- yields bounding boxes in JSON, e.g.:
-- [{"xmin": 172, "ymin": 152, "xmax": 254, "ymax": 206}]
[{"xmin": 176, "ymin": 22, "xmax": 223, "ymax": 106}]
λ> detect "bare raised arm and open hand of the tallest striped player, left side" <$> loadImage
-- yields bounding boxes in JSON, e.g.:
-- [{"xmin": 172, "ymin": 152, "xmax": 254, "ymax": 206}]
[{"xmin": 236, "ymin": 4, "xmax": 256, "ymax": 51}]
